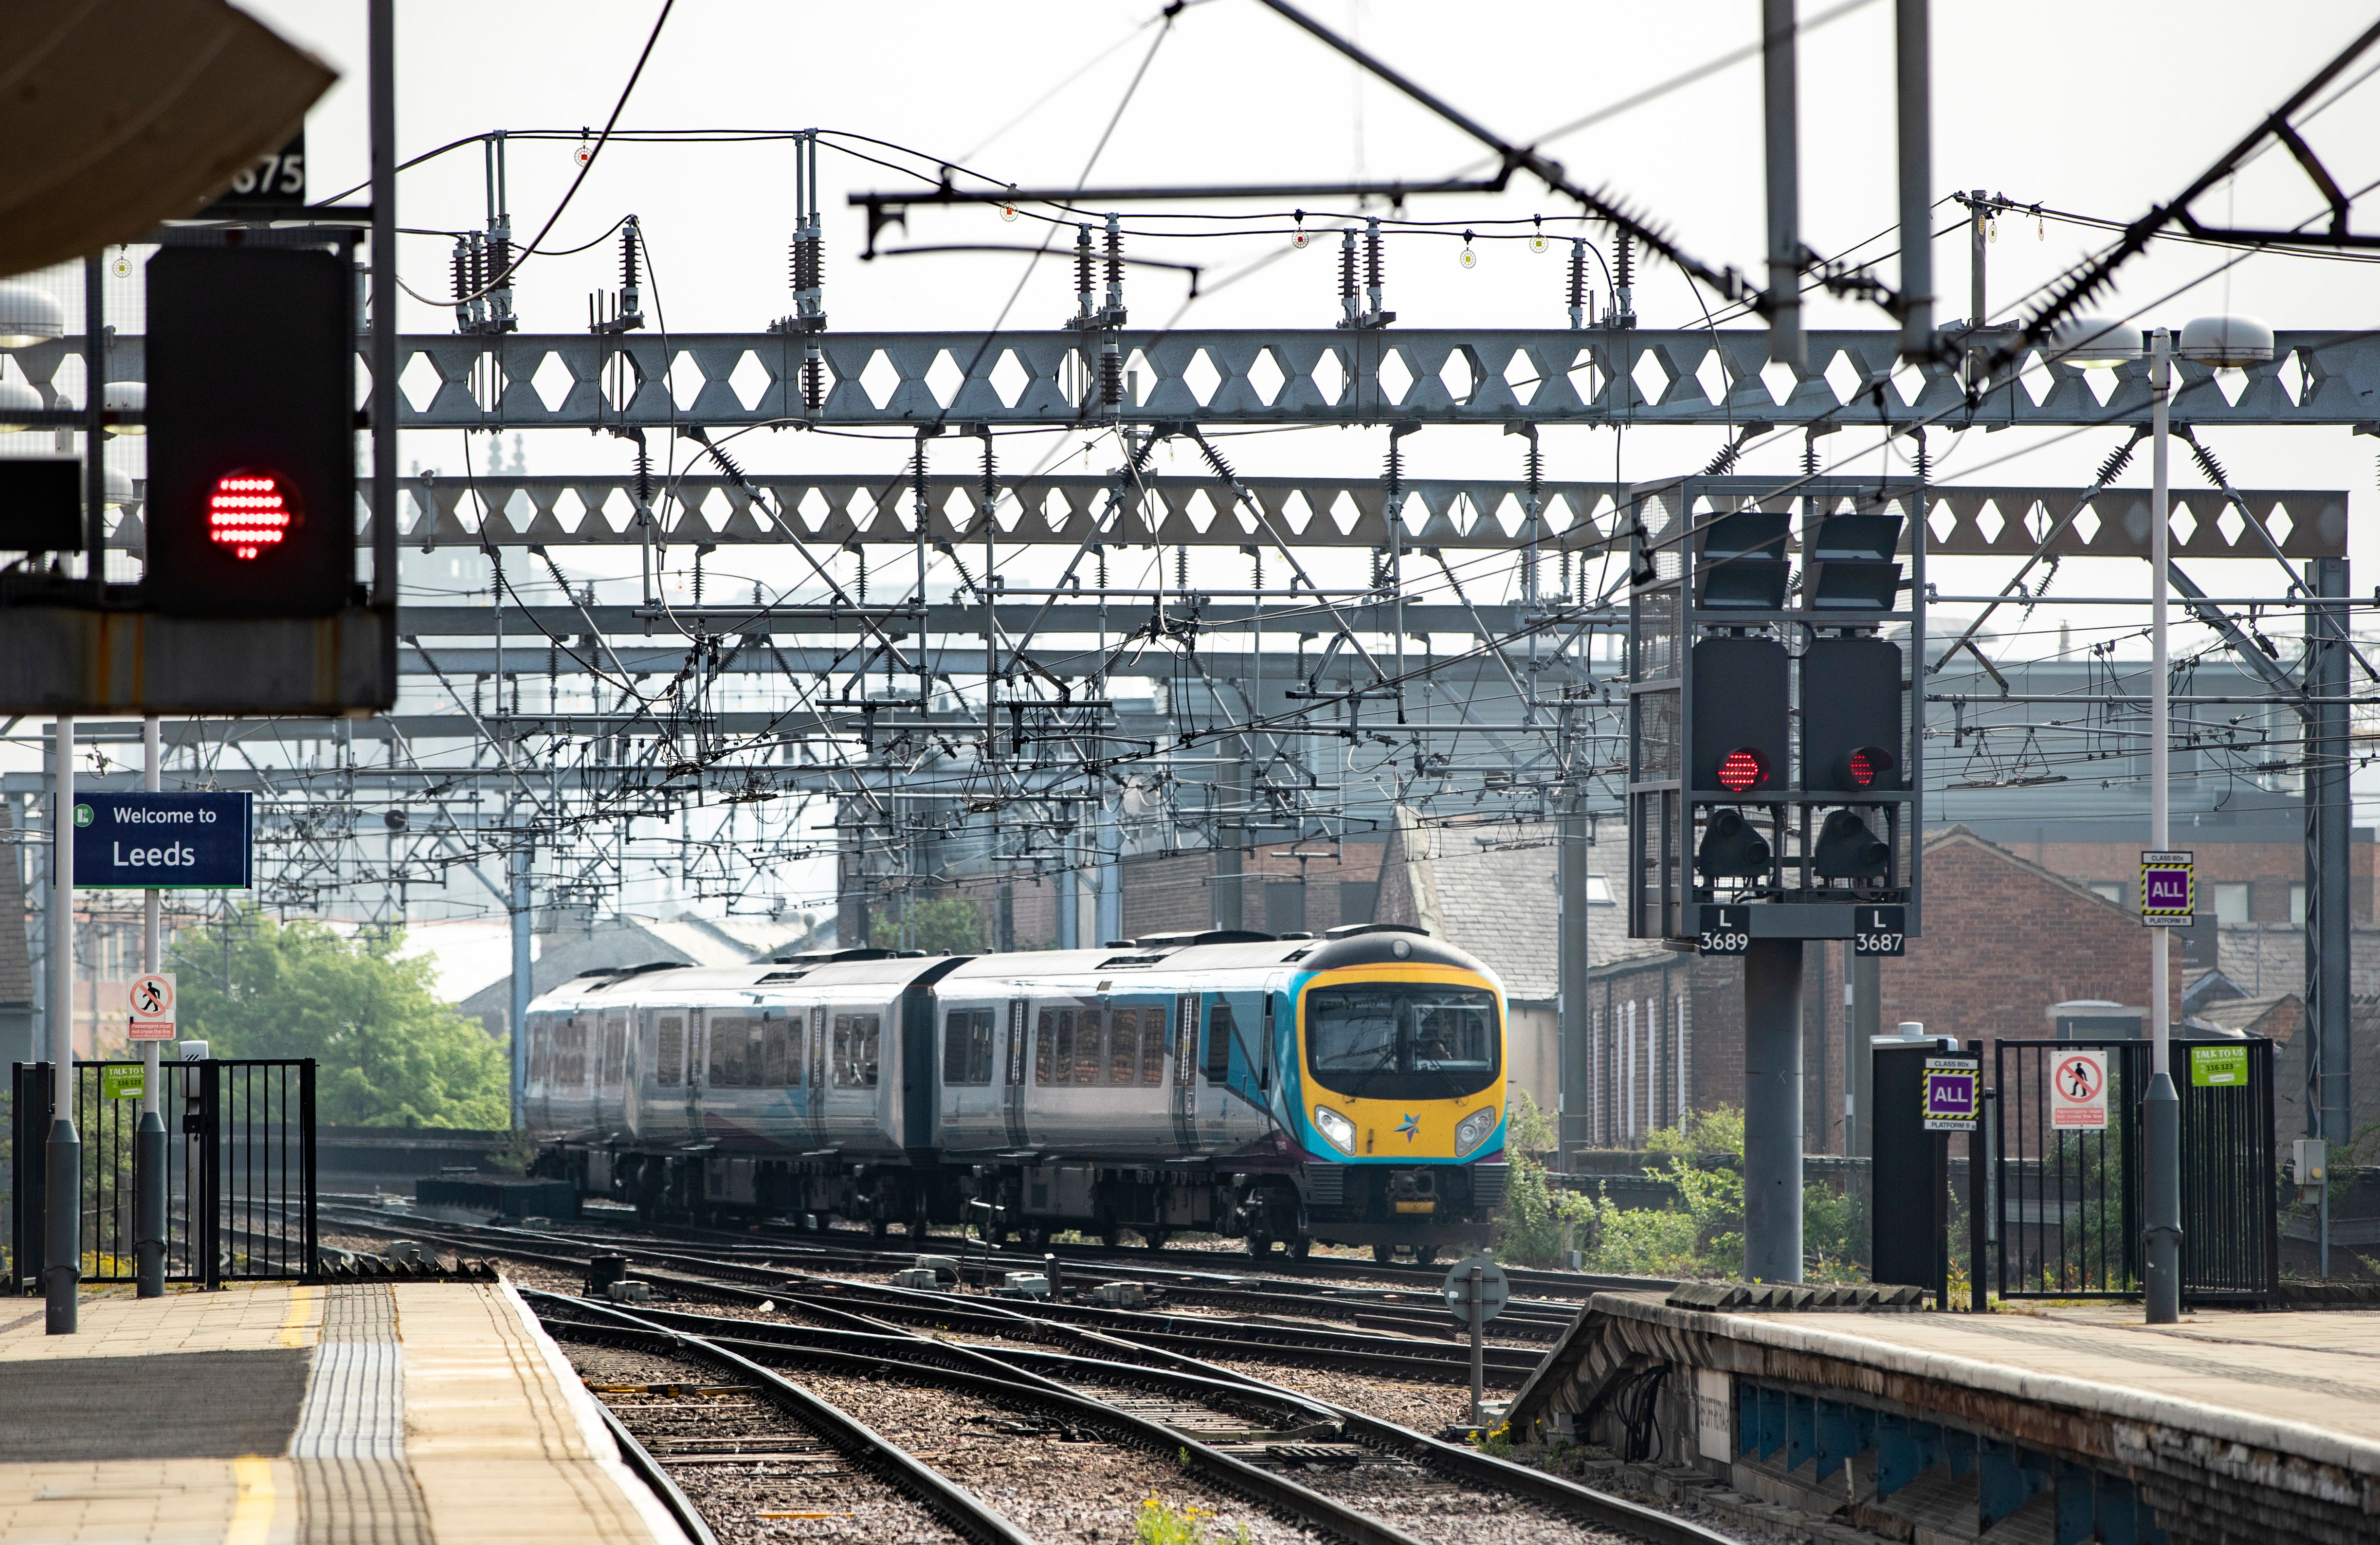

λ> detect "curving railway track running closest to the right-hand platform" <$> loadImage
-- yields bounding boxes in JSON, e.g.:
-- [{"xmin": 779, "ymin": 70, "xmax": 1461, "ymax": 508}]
[{"xmin": 526, "ymin": 1292, "xmax": 1726, "ymax": 1545}]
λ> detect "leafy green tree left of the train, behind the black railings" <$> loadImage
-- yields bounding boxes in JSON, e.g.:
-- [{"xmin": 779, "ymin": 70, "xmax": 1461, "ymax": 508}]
[{"xmin": 166, "ymin": 909, "xmax": 512, "ymax": 1128}]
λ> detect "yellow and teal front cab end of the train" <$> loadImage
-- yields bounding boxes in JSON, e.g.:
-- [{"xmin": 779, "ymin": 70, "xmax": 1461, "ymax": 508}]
[{"xmin": 1285, "ymin": 926, "xmax": 1507, "ymax": 1262}]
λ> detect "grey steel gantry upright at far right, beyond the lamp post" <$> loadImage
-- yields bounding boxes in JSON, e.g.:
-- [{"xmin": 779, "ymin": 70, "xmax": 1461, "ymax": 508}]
[{"xmin": 2306, "ymin": 557, "xmax": 2354, "ymax": 1276}]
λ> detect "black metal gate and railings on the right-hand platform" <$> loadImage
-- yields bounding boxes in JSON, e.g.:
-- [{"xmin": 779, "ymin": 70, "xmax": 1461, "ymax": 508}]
[{"xmin": 1992, "ymin": 1040, "xmax": 2280, "ymax": 1302}]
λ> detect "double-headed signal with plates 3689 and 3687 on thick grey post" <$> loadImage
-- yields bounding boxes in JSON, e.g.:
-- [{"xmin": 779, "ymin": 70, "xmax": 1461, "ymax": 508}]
[{"xmin": 1628, "ymin": 476, "xmax": 1926, "ymax": 1281}]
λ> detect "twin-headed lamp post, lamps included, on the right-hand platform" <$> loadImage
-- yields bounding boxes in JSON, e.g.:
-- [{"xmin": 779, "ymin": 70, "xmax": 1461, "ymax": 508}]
[{"xmin": 2052, "ymin": 317, "xmax": 2273, "ymax": 1326}]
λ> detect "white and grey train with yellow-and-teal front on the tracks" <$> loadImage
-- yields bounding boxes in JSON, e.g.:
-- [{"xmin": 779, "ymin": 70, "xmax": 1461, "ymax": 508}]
[{"xmin": 526, "ymin": 924, "xmax": 1507, "ymax": 1262}]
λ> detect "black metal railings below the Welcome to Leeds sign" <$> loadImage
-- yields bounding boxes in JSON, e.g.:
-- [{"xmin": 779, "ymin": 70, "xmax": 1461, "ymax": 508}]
[{"xmin": 7, "ymin": 1057, "xmax": 317, "ymax": 1292}]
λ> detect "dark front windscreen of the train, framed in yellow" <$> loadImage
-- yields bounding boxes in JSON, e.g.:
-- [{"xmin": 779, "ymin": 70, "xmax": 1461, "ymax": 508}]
[{"xmin": 1304, "ymin": 981, "xmax": 1502, "ymax": 1100}]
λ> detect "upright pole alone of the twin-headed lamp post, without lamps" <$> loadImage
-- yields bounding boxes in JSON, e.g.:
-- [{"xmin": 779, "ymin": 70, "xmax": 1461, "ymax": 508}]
[{"xmin": 2142, "ymin": 328, "xmax": 2182, "ymax": 1326}]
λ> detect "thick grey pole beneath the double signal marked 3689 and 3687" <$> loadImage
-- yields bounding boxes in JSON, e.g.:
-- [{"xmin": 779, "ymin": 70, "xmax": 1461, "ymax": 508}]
[{"xmin": 1744, "ymin": 938, "xmax": 1801, "ymax": 1283}]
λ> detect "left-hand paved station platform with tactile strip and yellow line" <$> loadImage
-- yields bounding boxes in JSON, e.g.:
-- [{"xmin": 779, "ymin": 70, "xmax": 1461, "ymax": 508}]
[{"xmin": 0, "ymin": 1283, "xmax": 686, "ymax": 1545}]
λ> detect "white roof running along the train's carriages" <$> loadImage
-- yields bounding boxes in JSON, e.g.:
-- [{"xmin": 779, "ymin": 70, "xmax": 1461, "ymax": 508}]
[{"xmin": 540, "ymin": 924, "xmax": 1495, "ymax": 1007}]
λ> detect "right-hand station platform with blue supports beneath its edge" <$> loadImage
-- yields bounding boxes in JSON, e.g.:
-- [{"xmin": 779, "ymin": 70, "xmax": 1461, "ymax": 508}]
[{"xmin": 1511, "ymin": 1288, "xmax": 2380, "ymax": 1545}]
